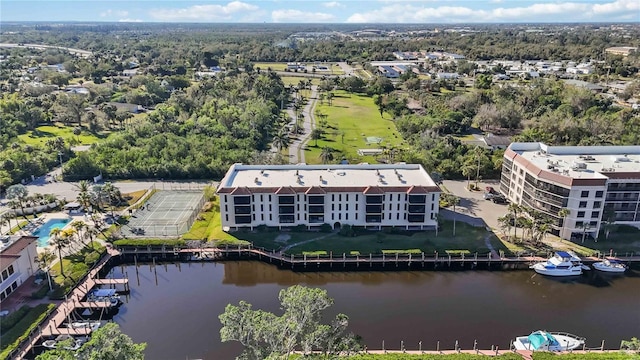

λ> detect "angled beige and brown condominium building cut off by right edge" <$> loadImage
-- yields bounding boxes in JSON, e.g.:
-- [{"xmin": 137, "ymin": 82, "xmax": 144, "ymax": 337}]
[{"xmin": 500, "ymin": 143, "xmax": 640, "ymax": 239}]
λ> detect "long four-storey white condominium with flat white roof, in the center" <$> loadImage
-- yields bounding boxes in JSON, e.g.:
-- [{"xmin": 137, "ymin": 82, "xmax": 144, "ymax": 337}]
[{"xmin": 217, "ymin": 164, "xmax": 440, "ymax": 230}]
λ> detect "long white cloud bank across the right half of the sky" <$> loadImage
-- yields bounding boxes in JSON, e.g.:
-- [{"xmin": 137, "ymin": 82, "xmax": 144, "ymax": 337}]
[{"xmin": 346, "ymin": 0, "xmax": 640, "ymax": 23}]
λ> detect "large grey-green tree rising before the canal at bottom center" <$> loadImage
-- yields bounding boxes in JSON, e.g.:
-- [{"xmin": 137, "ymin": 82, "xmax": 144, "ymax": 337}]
[{"xmin": 219, "ymin": 285, "xmax": 359, "ymax": 359}]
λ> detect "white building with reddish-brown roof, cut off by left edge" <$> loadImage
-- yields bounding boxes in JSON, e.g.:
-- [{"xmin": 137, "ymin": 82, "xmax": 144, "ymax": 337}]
[{"xmin": 0, "ymin": 235, "xmax": 38, "ymax": 301}]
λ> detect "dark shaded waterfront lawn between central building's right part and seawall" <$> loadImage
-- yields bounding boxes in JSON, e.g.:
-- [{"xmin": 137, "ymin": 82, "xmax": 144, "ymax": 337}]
[{"xmin": 288, "ymin": 221, "xmax": 506, "ymax": 256}]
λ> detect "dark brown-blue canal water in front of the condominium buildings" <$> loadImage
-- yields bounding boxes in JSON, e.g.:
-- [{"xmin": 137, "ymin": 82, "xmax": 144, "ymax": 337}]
[{"xmin": 109, "ymin": 261, "xmax": 640, "ymax": 359}]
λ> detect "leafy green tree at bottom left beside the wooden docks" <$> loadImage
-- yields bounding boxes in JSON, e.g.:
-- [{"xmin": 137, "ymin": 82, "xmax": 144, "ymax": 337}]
[{"xmin": 36, "ymin": 322, "xmax": 147, "ymax": 360}]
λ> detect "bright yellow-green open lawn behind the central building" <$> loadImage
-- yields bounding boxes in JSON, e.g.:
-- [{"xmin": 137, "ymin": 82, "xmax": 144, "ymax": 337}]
[{"xmin": 305, "ymin": 91, "xmax": 405, "ymax": 164}]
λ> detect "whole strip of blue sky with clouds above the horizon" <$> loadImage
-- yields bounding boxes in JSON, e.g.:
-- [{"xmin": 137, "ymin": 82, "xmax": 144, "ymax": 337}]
[{"xmin": 0, "ymin": 0, "xmax": 640, "ymax": 26}]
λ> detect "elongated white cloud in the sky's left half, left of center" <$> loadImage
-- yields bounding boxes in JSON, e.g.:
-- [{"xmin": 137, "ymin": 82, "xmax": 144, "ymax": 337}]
[{"xmin": 149, "ymin": 1, "xmax": 259, "ymax": 21}]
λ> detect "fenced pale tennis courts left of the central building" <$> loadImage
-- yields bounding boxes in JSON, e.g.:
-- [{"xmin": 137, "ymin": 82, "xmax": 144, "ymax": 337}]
[{"xmin": 122, "ymin": 191, "xmax": 204, "ymax": 238}]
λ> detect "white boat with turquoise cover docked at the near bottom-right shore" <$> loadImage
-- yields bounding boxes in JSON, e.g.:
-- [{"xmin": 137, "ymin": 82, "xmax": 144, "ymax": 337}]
[{"xmin": 513, "ymin": 330, "xmax": 585, "ymax": 351}]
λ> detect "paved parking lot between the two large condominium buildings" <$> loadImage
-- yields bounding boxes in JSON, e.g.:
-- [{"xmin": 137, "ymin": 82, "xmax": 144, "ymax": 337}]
[{"xmin": 442, "ymin": 180, "xmax": 508, "ymax": 230}]
